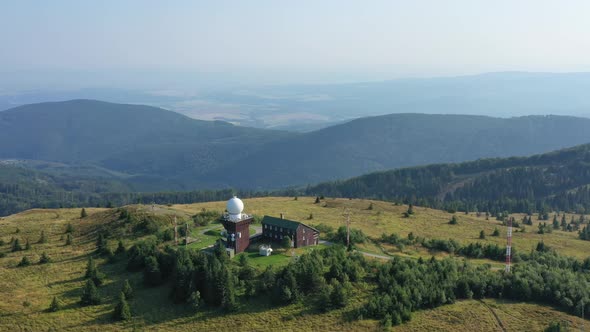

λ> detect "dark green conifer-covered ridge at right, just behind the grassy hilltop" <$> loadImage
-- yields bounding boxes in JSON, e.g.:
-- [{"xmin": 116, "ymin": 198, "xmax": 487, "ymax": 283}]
[{"xmin": 306, "ymin": 144, "xmax": 590, "ymax": 213}]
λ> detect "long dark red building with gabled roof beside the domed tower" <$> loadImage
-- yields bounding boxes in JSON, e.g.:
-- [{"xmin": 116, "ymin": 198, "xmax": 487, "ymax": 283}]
[{"xmin": 262, "ymin": 216, "xmax": 320, "ymax": 248}]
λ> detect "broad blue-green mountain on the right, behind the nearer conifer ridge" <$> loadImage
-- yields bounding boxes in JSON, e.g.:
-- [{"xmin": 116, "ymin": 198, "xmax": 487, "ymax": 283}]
[{"xmin": 213, "ymin": 114, "xmax": 590, "ymax": 188}]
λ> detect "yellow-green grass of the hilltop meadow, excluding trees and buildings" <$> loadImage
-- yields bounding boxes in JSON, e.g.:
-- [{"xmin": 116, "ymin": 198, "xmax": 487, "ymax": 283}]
[{"xmin": 0, "ymin": 197, "xmax": 590, "ymax": 331}]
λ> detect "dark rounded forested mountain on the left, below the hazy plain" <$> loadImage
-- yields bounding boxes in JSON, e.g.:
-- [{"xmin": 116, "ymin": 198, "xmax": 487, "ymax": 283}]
[{"xmin": 0, "ymin": 100, "xmax": 290, "ymax": 187}]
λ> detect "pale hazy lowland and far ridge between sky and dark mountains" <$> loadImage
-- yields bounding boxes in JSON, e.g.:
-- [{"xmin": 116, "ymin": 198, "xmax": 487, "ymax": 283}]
[{"xmin": 0, "ymin": 72, "xmax": 590, "ymax": 132}]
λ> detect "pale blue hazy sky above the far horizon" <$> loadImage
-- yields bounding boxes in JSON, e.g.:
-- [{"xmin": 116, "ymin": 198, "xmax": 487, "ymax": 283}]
[{"xmin": 0, "ymin": 0, "xmax": 590, "ymax": 89}]
